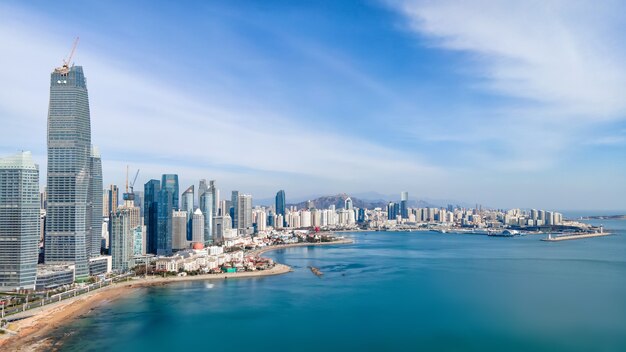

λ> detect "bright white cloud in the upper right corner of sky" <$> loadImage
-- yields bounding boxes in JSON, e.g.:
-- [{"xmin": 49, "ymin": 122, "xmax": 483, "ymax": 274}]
[{"xmin": 392, "ymin": 0, "xmax": 626, "ymax": 120}]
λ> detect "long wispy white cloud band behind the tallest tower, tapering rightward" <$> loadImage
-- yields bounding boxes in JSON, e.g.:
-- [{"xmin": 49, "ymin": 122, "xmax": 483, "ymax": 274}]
[{"xmin": 0, "ymin": 4, "xmax": 441, "ymax": 198}]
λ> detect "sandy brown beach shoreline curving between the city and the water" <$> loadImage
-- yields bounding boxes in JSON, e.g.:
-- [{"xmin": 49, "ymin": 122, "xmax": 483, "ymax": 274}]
[{"xmin": 0, "ymin": 239, "xmax": 354, "ymax": 351}]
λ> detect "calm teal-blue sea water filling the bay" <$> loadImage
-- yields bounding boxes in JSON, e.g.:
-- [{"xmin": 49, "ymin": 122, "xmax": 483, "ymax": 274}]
[{"xmin": 56, "ymin": 220, "xmax": 626, "ymax": 351}]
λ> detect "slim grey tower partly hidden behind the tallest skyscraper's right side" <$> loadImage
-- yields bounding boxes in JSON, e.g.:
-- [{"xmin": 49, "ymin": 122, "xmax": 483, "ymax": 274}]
[{"xmin": 87, "ymin": 147, "xmax": 102, "ymax": 258}]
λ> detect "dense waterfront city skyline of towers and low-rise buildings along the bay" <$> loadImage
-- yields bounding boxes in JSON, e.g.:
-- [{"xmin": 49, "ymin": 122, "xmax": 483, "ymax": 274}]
[{"xmin": 0, "ymin": 60, "xmax": 562, "ymax": 291}]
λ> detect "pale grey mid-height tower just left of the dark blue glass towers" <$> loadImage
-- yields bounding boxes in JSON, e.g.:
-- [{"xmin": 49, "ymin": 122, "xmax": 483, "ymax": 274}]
[{"xmin": 110, "ymin": 207, "xmax": 135, "ymax": 272}]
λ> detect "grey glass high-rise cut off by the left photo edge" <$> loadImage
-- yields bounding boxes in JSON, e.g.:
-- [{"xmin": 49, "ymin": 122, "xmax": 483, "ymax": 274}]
[{"xmin": 0, "ymin": 152, "xmax": 40, "ymax": 291}]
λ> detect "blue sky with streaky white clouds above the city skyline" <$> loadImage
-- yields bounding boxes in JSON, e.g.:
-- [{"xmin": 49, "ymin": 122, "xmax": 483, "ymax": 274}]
[{"xmin": 0, "ymin": 0, "xmax": 626, "ymax": 210}]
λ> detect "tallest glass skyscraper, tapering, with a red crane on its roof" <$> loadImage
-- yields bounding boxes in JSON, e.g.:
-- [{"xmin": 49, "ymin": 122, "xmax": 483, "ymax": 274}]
[{"xmin": 45, "ymin": 65, "xmax": 91, "ymax": 281}]
